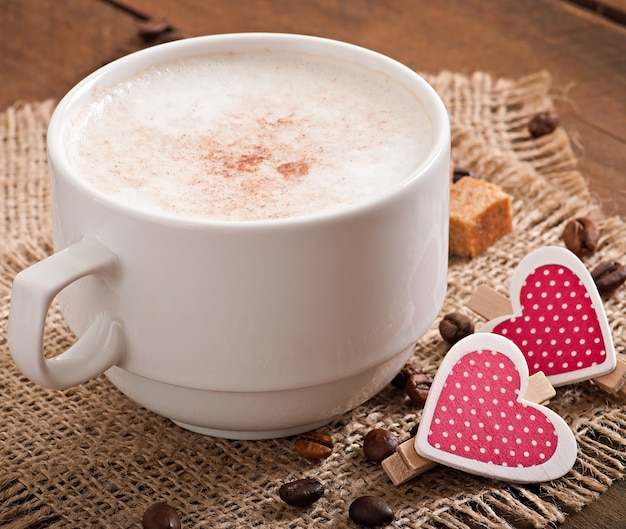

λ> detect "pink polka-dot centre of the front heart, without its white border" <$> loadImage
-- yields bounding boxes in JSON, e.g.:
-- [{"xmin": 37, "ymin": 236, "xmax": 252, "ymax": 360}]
[{"xmin": 428, "ymin": 350, "xmax": 557, "ymax": 467}]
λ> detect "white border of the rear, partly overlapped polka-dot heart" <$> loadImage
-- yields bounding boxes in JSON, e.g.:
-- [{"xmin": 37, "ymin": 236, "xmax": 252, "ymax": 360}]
[{"xmin": 476, "ymin": 246, "xmax": 617, "ymax": 387}]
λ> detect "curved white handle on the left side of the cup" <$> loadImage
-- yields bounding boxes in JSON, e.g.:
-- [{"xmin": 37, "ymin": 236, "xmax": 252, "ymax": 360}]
[{"xmin": 8, "ymin": 236, "xmax": 126, "ymax": 389}]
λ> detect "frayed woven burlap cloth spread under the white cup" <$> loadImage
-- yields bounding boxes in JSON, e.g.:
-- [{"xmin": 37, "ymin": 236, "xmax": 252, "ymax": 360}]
[{"xmin": 0, "ymin": 72, "xmax": 626, "ymax": 528}]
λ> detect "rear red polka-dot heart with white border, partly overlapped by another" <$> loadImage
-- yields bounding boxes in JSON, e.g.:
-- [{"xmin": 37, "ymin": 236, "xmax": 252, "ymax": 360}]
[{"xmin": 478, "ymin": 246, "xmax": 617, "ymax": 386}]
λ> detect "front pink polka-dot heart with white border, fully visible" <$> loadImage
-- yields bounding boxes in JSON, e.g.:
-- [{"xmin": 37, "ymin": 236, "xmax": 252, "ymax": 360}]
[{"xmin": 415, "ymin": 333, "xmax": 577, "ymax": 483}]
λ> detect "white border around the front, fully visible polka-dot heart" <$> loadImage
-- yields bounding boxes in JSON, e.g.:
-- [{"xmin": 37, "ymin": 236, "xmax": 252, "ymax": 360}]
[{"xmin": 415, "ymin": 333, "xmax": 578, "ymax": 483}]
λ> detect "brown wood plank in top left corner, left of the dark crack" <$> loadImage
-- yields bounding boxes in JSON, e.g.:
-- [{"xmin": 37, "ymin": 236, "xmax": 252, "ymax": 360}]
[{"xmin": 0, "ymin": 0, "xmax": 135, "ymax": 109}]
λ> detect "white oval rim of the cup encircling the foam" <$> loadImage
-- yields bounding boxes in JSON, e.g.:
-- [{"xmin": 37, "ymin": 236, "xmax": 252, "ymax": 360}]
[{"xmin": 46, "ymin": 32, "xmax": 450, "ymax": 229}]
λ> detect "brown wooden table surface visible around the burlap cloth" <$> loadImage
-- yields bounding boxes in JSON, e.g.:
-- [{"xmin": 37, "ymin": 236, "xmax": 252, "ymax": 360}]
[{"xmin": 0, "ymin": 0, "xmax": 626, "ymax": 529}]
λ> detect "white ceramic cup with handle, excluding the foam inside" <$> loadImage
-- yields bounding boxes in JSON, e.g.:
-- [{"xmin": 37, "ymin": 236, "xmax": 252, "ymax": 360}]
[{"xmin": 8, "ymin": 34, "xmax": 450, "ymax": 439}]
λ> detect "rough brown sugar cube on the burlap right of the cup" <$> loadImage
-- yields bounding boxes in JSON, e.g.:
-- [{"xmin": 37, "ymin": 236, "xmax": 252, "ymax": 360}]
[{"xmin": 450, "ymin": 178, "xmax": 513, "ymax": 258}]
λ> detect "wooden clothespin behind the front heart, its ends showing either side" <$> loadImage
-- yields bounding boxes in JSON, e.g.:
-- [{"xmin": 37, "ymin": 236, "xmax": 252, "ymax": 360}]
[{"xmin": 382, "ymin": 373, "xmax": 556, "ymax": 486}]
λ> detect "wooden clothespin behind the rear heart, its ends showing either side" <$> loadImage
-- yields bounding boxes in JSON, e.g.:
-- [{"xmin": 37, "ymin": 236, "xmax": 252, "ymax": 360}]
[{"xmin": 467, "ymin": 285, "xmax": 626, "ymax": 397}]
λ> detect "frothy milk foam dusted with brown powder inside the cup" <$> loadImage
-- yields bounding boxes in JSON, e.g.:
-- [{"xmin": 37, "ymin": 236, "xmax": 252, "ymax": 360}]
[{"xmin": 66, "ymin": 51, "xmax": 432, "ymax": 220}]
